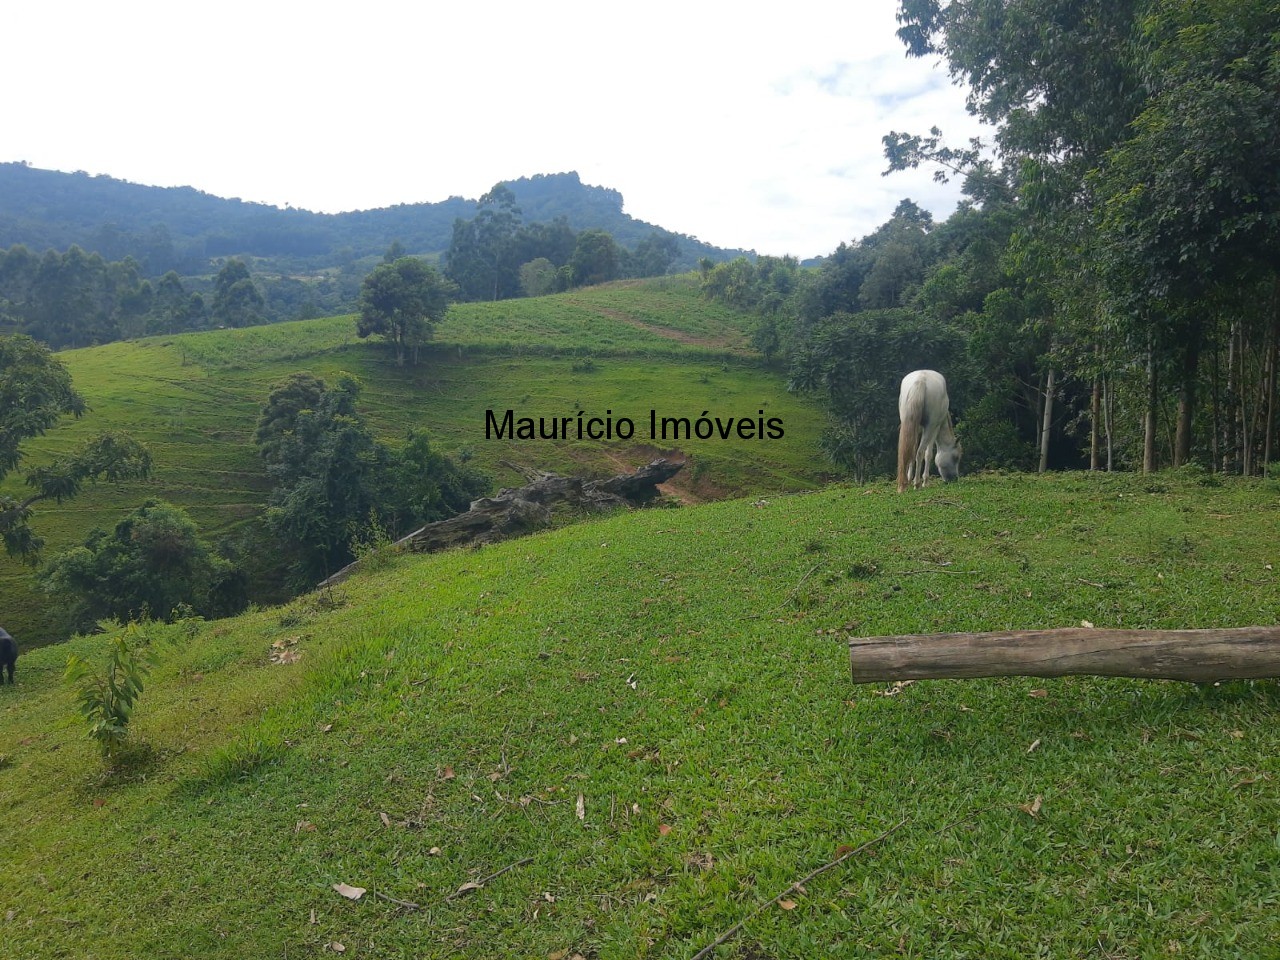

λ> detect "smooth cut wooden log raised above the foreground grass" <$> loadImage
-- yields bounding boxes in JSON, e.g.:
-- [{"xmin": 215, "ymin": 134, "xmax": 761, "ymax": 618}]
[{"xmin": 849, "ymin": 627, "xmax": 1280, "ymax": 684}]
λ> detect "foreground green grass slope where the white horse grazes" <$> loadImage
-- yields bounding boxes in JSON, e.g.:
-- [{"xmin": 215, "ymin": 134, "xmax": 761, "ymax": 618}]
[{"xmin": 0, "ymin": 475, "xmax": 1280, "ymax": 960}]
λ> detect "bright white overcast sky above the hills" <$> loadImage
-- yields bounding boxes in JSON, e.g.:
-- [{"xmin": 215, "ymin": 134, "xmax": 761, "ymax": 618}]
[{"xmin": 10, "ymin": 0, "xmax": 984, "ymax": 257}]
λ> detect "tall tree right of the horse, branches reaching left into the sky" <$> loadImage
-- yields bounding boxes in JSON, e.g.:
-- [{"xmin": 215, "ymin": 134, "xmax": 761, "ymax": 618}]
[{"xmin": 884, "ymin": 0, "xmax": 1146, "ymax": 463}]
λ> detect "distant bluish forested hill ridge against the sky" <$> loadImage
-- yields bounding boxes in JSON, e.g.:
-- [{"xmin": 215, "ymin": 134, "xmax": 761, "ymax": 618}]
[{"xmin": 0, "ymin": 163, "xmax": 742, "ymax": 276}]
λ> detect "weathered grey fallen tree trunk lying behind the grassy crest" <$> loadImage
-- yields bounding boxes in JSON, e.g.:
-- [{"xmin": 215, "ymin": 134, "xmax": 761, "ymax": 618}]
[{"xmin": 320, "ymin": 460, "xmax": 685, "ymax": 586}]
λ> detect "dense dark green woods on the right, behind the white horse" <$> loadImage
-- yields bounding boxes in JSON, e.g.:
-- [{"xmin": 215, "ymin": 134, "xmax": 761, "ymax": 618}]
[{"xmin": 703, "ymin": 0, "xmax": 1280, "ymax": 476}]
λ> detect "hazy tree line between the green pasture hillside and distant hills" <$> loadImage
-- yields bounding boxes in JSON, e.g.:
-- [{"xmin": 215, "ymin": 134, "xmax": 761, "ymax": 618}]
[{"xmin": 0, "ymin": 200, "xmax": 680, "ymax": 349}]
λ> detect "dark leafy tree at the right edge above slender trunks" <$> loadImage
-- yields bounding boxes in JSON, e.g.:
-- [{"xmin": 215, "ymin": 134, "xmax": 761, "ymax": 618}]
[{"xmin": 1092, "ymin": 0, "xmax": 1280, "ymax": 472}]
